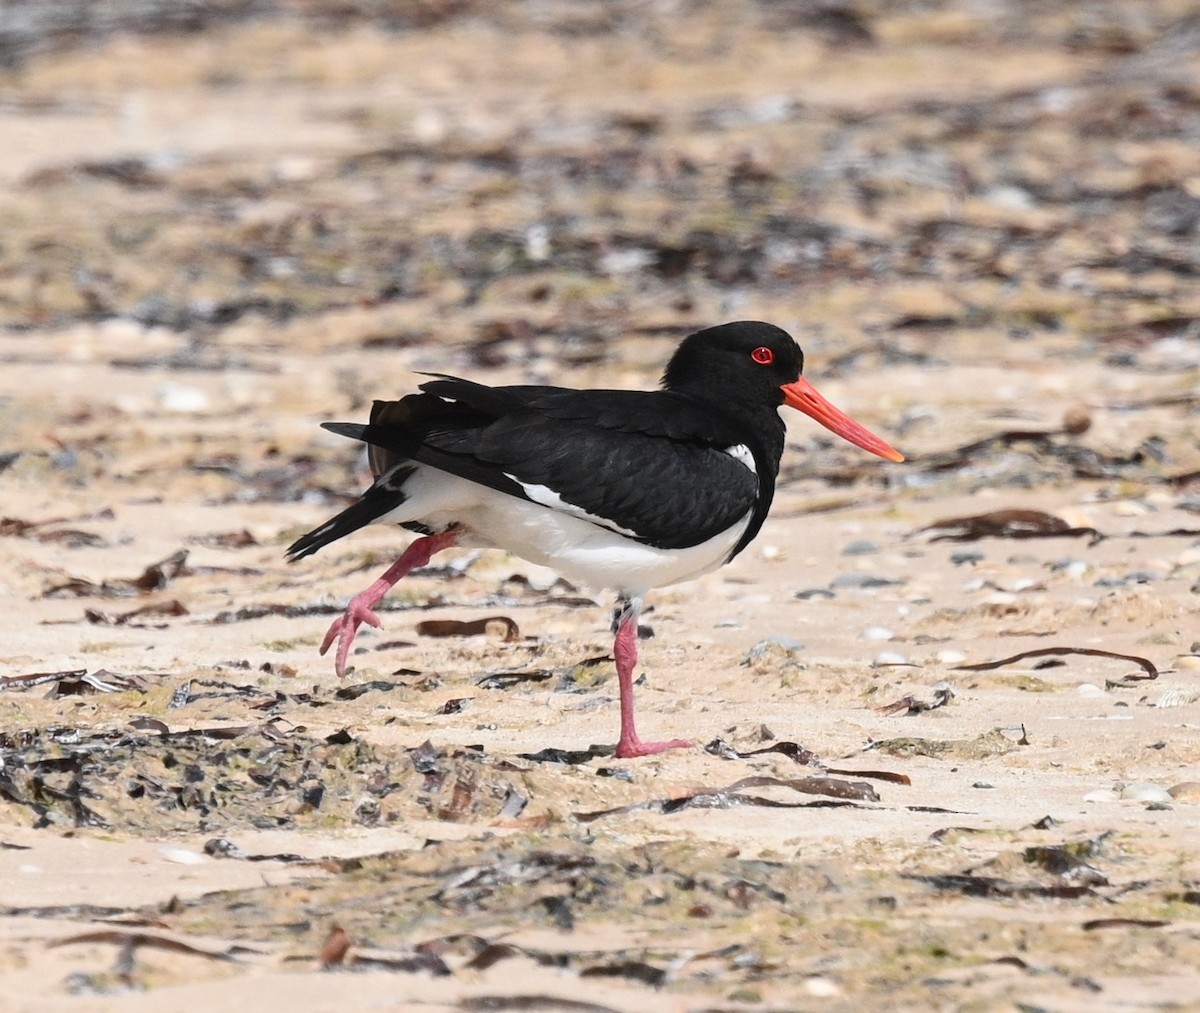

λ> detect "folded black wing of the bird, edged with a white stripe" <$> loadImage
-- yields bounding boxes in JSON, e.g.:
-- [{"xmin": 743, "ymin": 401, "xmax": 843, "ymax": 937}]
[{"xmin": 325, "ymin": 377, "xmax": 774, "ymax": 551}]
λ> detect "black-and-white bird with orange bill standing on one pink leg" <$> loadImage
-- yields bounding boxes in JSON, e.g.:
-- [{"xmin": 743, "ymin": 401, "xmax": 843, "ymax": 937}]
[{"xmin": 286, "ymin": 320, "xmax": 904, "ymax": 759}]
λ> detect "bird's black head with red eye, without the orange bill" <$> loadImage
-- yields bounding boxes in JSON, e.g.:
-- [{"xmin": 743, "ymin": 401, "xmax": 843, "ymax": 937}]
[{"xmin": 662, "ymin": 320, "xmax": 804, "ymax": 408}]
